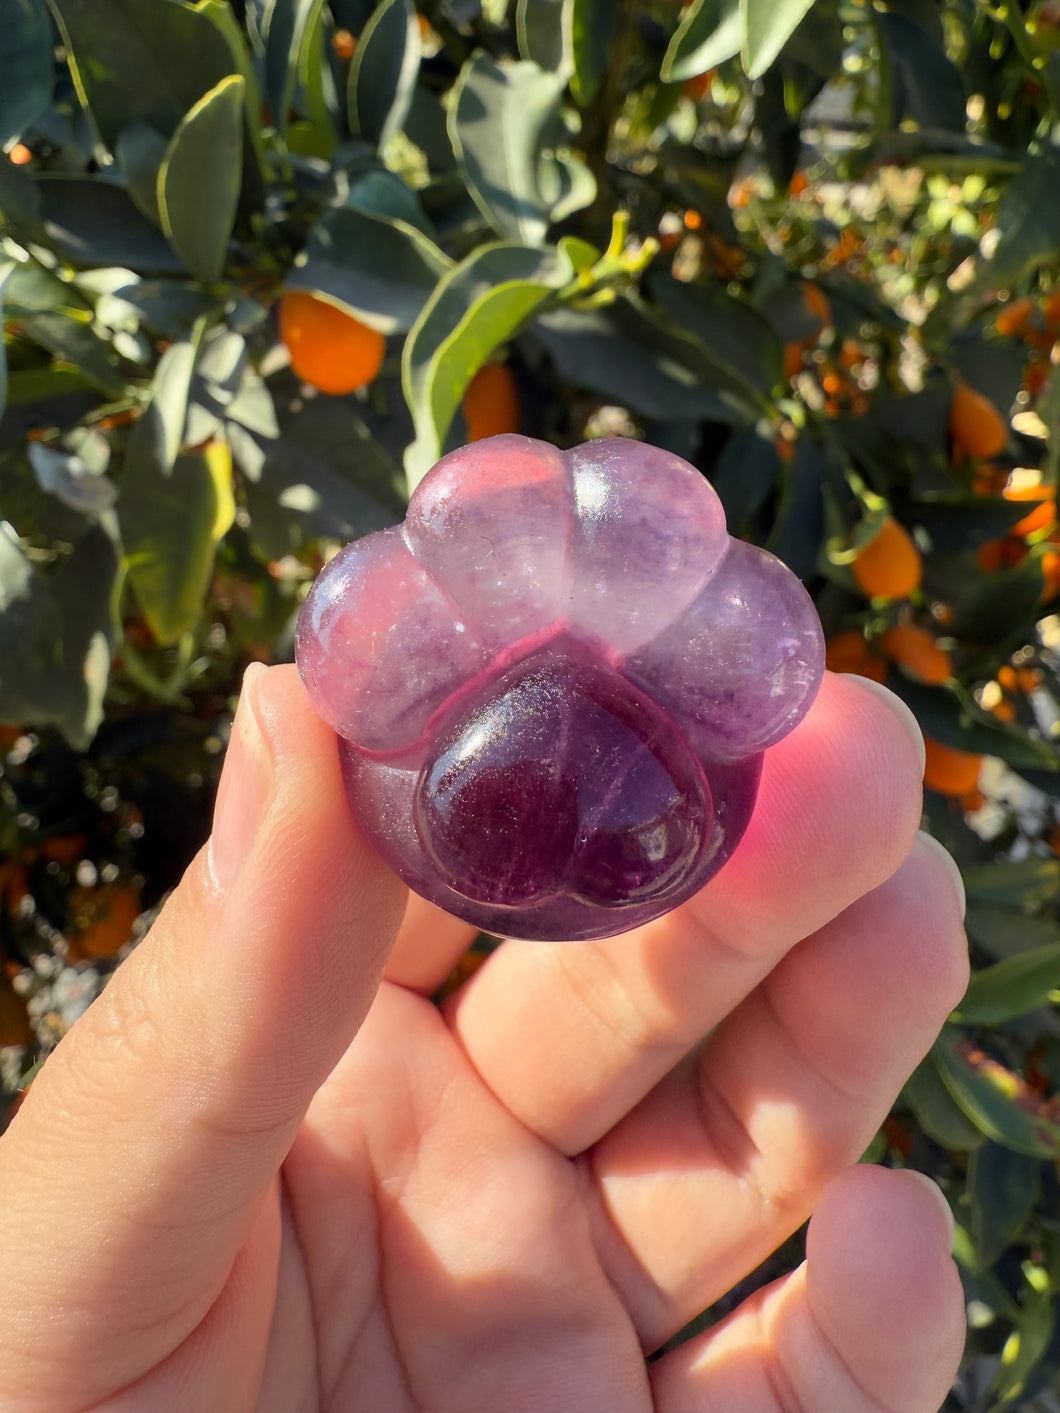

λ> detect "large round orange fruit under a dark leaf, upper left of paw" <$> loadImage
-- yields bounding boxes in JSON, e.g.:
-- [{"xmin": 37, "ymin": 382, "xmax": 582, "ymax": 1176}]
[{"xmin": 280, "ymin": 290, "xmax": 386, "ymax": 396}]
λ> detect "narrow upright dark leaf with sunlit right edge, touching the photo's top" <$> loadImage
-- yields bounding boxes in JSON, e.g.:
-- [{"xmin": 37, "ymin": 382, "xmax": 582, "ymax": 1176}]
[{"xmin": 348, "ymin": 0, "xmax": 420, "ymax": 147}]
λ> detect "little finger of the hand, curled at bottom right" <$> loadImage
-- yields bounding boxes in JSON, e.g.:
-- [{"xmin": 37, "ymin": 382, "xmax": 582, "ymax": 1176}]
[{"xmin": 652, "ymin": 1167, "xmax": 965, "ymax": 1413}]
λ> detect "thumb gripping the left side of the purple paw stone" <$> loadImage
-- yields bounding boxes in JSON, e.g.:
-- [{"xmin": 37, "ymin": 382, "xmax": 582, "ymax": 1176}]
[{"xmin": 0, "ymin": 667, "xmax": 404, "ymax": 1406}]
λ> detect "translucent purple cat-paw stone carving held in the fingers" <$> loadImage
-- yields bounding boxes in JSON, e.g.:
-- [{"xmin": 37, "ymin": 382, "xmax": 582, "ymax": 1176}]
[{"xmin": 297, "ymin": 437, "xmax": 824, "ymax": 938}]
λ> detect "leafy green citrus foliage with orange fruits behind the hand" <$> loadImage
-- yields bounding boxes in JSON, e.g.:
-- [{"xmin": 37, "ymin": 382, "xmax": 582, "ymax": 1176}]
[{"xmin": 0, "ymin": 0, "xmax": 1060, "ymax": 1413}]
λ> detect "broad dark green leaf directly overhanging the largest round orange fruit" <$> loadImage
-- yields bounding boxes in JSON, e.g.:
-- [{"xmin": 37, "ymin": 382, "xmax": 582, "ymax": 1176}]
[{"xmin": 285, "ymin": 206, "xmax": 452, "ymax": 333}]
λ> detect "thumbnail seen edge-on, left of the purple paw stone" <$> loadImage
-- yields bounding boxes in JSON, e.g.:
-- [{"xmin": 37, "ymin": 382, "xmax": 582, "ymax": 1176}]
[{"xmin": 208, "ymin": 663, "xmax": 273, "ymax": 893}]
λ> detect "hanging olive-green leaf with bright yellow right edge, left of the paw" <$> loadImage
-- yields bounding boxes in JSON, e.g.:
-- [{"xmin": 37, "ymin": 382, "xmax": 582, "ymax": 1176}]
[{"xmin": 117, "ymin": 417, "xmax": 233, "ymax": 643}]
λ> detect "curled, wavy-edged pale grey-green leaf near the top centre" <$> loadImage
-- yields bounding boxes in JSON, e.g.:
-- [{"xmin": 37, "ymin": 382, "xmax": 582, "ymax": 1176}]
[{"xmin": 449, "ymin": 51, "xmax": 595, "ymax": 246}]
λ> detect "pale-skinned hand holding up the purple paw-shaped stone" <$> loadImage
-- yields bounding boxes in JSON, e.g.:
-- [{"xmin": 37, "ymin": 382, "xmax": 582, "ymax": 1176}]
[{"xmin": 0, "ymin": 667, "xmax": 967, "ymax": 1413}]
